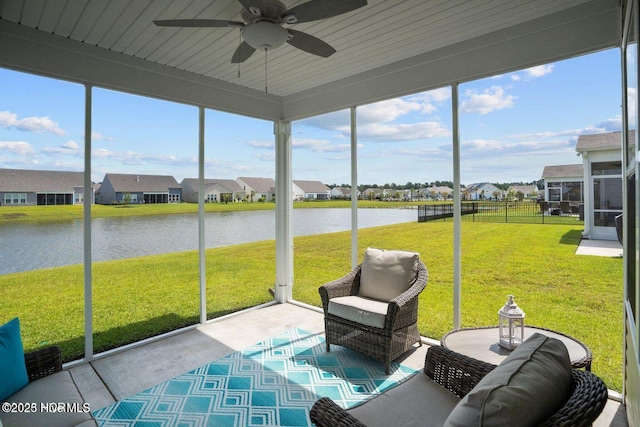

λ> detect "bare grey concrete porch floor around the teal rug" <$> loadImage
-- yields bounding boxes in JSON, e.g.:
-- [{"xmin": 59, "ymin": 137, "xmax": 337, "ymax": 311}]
[{"xmin": 69, "ymin": 304, "xmax": 628, "ymax": 427}]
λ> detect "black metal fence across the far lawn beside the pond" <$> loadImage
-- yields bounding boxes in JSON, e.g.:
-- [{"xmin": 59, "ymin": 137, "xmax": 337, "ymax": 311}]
[{"xmin": 418, "ymin": 201, "xmax": 584, "ymax": 224}]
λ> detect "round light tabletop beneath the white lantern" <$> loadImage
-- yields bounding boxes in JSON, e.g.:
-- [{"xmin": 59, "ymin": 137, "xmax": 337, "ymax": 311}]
[{"xmin": 440, "ymin": 326, "xmax": 592, "ymax": 371}]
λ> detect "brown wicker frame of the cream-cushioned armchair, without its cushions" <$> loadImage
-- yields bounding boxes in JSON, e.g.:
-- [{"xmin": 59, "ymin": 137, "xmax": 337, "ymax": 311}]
[{"xmin": 319, "ymin": 251, "xmax": 428, "ymax": 374}]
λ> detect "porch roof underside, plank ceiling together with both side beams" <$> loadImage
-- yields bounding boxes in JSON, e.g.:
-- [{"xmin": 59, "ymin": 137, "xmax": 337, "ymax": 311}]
[{"xmin": 0, "ymin": 0, "xmax": 622, "ymax": 120}]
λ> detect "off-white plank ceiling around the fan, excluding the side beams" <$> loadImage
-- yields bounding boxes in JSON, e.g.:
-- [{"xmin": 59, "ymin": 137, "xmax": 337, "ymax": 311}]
[{"xmin": 0, "ymin": 0, "xmax": 608, "ymax": 97}]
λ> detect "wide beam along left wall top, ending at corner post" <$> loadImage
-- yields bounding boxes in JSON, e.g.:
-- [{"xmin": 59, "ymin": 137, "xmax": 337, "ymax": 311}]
[{"xmin": 0, "ymin": 20, "xmax": 282, "ymax": 120}]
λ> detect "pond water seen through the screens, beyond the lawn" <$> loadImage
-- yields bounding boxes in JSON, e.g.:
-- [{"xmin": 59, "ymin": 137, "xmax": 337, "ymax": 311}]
[{"xmin": 0, "ymin": 209, "xmax": 418, "ymax": 274}]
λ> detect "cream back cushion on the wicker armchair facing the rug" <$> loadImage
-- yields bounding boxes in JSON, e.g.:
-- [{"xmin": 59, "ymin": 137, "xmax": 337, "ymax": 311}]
[{"xmin": 359, "ymin": 248, "xmax": 420, "ymax": 302}]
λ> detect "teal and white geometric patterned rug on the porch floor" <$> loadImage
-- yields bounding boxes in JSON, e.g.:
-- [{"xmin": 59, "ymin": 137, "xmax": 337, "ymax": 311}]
[{"xmin": 93, "ymin": 329, "xmax": 417, "ymax": 427}]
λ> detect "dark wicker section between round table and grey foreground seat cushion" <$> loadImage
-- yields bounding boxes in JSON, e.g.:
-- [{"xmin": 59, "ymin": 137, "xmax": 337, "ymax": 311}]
[{"xmin": 424, "ymin": 346, "xmax": 496, "ymax": 398}]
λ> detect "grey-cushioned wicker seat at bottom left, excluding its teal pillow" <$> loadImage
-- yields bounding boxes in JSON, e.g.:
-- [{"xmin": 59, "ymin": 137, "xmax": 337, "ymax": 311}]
[{"xmin": 0, "ymin": 346, "xmax": 98, "ymax": 427}]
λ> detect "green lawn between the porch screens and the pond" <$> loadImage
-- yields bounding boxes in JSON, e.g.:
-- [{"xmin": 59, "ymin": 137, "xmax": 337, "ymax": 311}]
[{"xmin": 0, "ymin": 221, "xmax": 623, "ymax": 391}]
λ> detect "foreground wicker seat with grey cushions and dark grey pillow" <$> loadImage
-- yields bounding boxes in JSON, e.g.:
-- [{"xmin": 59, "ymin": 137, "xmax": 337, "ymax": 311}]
[{"xmin": 310, "ymin": 334, "xmax": 608, "ymax": 427}]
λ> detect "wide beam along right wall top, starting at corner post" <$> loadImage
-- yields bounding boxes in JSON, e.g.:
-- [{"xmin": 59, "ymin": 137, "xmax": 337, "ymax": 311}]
[{"xmin": 283, "ymin": 0, "xmax": 621, "ymax": 120}]
